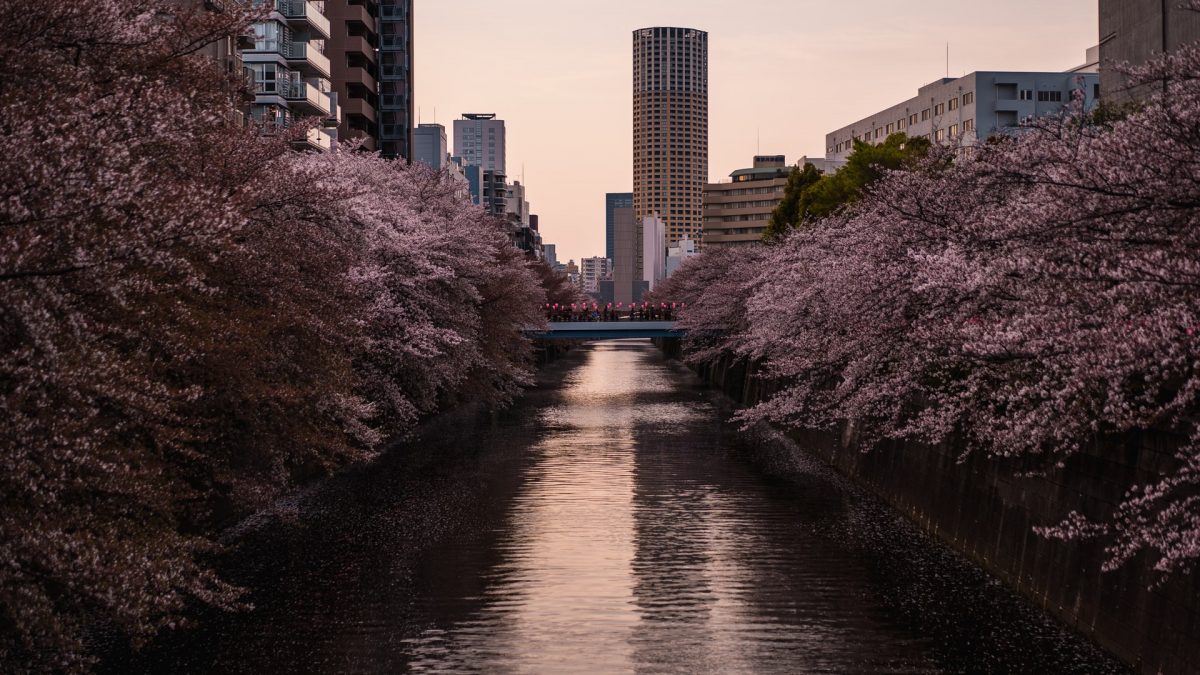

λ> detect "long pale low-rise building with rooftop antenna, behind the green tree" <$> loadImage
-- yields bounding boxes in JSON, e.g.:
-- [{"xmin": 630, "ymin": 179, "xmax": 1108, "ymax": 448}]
[{"xmin": 826, "ymin": 66, "xmax": 1100, "ymax": 160}]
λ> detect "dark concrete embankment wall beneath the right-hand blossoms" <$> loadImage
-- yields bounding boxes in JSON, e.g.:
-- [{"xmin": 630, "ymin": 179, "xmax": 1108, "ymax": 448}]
[{"xmin": 664, "ymin": 345, "xmax": 1200, "ymax": 674}]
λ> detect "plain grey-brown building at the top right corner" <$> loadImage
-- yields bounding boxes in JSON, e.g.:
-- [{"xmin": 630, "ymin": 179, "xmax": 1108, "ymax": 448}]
[{"xmin": 1100, "ymin": 0, "xmax": 1200, "ymax": 103}]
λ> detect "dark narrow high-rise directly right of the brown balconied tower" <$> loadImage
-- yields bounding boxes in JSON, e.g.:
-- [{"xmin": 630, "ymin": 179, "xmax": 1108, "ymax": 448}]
[{"xmin": 379, "ymin": 0, "xmax": 414, "ymax": 161}]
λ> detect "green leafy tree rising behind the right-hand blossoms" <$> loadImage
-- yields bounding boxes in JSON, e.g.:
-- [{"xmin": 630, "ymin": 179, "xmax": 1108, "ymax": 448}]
[{"xmin": 764, "ymin": 133, "xmax": 930, "ymax": 240}]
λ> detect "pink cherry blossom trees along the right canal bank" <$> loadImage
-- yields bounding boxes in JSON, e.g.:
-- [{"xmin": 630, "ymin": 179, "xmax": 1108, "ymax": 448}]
[{"xmin": 682, "ymin": 47, "xmax": 1200, "ymax": 574}]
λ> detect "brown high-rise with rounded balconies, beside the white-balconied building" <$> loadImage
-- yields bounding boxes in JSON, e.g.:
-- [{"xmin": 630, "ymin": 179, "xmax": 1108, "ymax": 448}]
[{"xmin": 328, "ymin": 0, "xmax": 379, "ymax": 151}]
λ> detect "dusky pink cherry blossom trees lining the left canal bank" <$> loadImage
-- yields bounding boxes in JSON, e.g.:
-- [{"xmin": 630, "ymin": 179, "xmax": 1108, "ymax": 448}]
[{"xmin": 0, "ymin": 0, "xmax": 544, "ymax": 671}]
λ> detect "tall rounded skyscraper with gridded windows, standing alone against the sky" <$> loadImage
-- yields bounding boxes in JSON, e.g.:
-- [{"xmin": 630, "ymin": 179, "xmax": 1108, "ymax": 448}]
[{"xmin": 634, "ymin": 28, "xmax": 708, "ymax": 245}]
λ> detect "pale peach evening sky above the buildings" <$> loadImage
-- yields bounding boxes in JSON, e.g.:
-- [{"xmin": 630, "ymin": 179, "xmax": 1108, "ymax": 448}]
[{"xmin": 414, "ymin": 0, "xmax": 1099, "ymax": 263}]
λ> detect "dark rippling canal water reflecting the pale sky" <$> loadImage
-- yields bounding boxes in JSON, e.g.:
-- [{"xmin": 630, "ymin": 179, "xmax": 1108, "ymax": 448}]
[{"xmin": 126, "ymin": 341, "xmax": 1123, "ymax": 674}]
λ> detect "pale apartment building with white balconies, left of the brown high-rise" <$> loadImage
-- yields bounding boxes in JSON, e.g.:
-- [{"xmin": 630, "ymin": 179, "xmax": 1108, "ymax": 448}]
[{"xmin": 241, "ymin": 0, "xmax": 338, "ymax": 151}]
